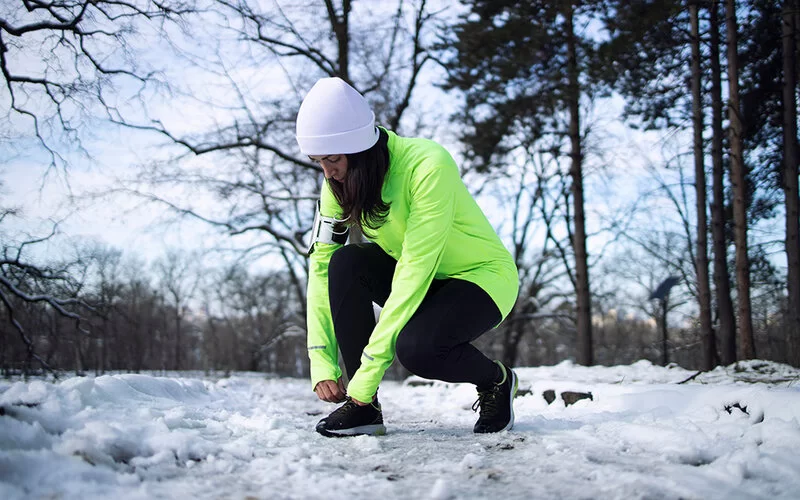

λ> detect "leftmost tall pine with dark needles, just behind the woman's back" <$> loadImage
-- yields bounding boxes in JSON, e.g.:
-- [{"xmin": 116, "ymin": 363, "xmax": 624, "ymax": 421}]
[{"xmin": 444, "ymin": 0, "xmax": 603, "ymax": 365}]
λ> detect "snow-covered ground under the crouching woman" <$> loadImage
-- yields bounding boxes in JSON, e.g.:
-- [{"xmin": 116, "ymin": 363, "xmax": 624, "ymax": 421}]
[{"xmin": 0, "ymin": 361, "xmax": 800, "ymax": 500}]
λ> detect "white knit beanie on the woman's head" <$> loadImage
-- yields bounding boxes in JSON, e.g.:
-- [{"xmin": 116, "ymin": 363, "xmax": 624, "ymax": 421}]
[{"xmin": 296, "ymin": 78, "xmax": 379, "ymax": 155}]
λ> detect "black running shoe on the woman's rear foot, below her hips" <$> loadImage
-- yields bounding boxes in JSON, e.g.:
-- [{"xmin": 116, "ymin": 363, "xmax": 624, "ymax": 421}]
[{"xmin": 472, "ymin": 361, "xmax": 519, "ymax": 434}]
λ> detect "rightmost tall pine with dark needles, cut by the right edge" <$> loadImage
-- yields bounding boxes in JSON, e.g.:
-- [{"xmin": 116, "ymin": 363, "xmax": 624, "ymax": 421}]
[{"xmin": 739, "ymin": 0, "xmax": 800, "ymax": 363}]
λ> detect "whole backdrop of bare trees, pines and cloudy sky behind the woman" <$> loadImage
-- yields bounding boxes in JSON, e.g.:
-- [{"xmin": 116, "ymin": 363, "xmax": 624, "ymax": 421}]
[{"xmin": 0, "ymin": 0, "xmax": 800, "ymax": 376}]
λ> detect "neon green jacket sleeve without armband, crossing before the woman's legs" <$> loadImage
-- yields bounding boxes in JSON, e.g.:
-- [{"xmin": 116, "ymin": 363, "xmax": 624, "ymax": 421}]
[{"xmin": 347, "ymin": 155, "xmax": 462, "ymax": 402}]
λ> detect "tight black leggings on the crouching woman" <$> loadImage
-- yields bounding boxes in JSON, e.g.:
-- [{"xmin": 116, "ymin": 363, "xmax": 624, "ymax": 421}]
[{"xmin": 328, "ymin": 243, "xmax": 501, "ymax": 387}]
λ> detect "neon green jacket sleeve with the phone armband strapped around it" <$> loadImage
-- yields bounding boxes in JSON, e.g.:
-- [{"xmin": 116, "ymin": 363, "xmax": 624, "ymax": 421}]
[{"xmin": 306, "ymin": 182, "xmax": 342, "ymax": 390}]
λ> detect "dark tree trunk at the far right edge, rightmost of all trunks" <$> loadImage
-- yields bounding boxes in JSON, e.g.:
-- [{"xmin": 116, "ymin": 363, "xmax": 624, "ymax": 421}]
[{"xmin": 781, "ymin": 0, "xmax": 800, "ymax": 365}]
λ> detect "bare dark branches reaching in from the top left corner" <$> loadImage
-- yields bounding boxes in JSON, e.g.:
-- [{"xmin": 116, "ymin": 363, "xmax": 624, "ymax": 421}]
[{"xmin": 0, "ymin": 0, "xmax": 192, "ymax": 172}]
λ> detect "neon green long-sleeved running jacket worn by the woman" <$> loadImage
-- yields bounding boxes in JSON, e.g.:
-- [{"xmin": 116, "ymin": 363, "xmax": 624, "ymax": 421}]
[{"xmin": 307, "ymin": 131, "xmax": 519, "ymax": 401}]
